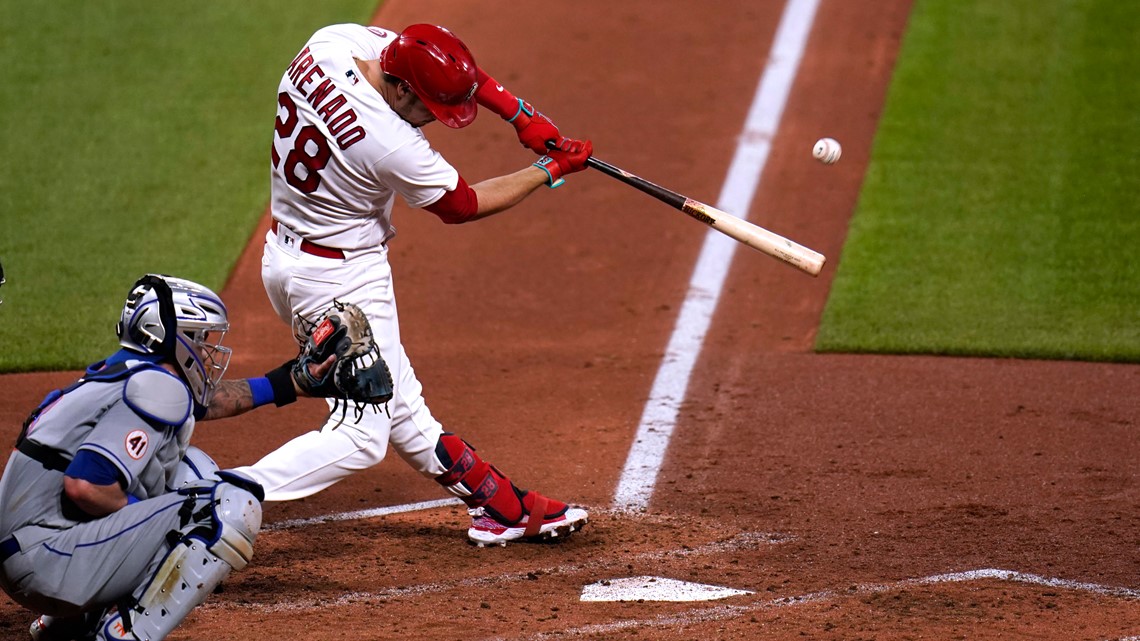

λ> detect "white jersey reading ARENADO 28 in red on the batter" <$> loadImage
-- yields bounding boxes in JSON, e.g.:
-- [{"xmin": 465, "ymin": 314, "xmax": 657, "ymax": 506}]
[{"xmin": 271, "ymin": 24, "xmax": 459, "ymax": 251}]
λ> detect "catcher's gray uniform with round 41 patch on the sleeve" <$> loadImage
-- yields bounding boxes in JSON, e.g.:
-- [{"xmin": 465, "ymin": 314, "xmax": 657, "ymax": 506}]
[{"xmin": 0, "ymin": 350, "xmax": 260, "ymax": 639}]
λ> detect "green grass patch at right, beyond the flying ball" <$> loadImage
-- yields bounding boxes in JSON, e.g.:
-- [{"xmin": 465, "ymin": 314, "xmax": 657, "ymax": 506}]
[{"xmin": 816, "ymin": 0, "xmax": 1140, "ymax": 362}]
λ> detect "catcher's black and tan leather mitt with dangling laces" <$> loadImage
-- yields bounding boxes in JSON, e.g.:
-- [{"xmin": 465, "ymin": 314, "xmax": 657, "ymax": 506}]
[{"xmin": 292, "ymin": 300, "xmax": 393, "ymax": 420}]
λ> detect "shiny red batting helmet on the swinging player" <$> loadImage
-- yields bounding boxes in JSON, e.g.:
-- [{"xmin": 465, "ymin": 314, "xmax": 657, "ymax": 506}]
[{"xmin": 380, "ymin": 24, "xmax": 479, "ymax": 129}]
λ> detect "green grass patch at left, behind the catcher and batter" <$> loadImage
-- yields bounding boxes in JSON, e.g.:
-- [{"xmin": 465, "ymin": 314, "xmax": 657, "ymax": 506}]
[{"xmin": 0, "ymin": 0, "xmax": 376, "ymax": 371}]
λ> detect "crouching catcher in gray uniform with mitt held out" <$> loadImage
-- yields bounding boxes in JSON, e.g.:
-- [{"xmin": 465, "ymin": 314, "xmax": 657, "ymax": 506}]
[{"xmin": 0, "ymin": 274, "xmax": 391, "ymax": 641}]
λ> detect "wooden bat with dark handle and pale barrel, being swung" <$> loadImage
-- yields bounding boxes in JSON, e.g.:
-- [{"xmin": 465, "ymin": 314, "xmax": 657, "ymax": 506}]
[{"xmin": 586, "ymin": 156, "xmax": 827, "ymax": 276}]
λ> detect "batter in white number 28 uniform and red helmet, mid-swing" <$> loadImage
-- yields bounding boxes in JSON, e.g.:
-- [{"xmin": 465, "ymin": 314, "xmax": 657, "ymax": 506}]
[{"xmin": 242, "ymin": 24, "xmax": 593, "ymax": 545}]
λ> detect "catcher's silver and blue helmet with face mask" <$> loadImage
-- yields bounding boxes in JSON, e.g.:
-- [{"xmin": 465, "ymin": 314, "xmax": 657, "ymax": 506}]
[{"xmin": 115, "ymin": 274, "xmax": 230, "ymax": 408}]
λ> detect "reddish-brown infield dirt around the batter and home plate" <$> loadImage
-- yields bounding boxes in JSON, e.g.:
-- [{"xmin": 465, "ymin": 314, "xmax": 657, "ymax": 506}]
[{"xmin": 0, "ymin": 0, "xmax": 1140, "ymax": 641}]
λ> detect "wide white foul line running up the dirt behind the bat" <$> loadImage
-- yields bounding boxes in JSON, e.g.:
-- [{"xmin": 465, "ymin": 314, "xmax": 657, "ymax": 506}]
[{"xmin": 613, "ymin": 0, "xmax": 820, "ymax": 510}]
